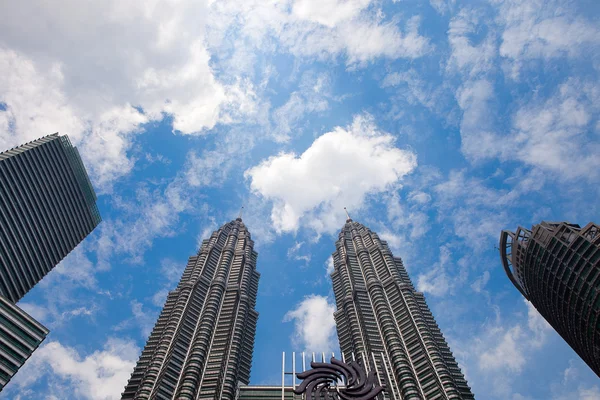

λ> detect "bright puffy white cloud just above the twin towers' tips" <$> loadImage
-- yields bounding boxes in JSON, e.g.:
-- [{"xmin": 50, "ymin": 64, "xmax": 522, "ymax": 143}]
[{"xmin": 244, "ymin": 116, "xmax": 417, "ymax": 233}]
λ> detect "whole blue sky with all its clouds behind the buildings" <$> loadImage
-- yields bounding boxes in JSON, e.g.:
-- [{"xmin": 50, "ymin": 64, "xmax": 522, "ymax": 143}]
[{"xmin": 0, "ymin": 0, "xmax": 600, "ymax": 400}]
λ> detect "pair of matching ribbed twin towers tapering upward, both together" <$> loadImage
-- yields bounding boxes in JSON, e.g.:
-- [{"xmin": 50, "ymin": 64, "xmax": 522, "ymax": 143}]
[{"xmin": 122, "ymin": 218, "xmax": 474, "ymax": 400}]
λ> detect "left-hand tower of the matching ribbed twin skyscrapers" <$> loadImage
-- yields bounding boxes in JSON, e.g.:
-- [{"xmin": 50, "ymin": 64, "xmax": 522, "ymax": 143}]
[{"xmin": 121, "ymin": 218, "xmax": 260, "ymax": 400}]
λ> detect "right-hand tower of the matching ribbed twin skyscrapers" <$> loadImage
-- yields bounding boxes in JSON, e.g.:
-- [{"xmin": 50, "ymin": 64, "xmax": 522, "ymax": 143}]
[{"xmin": 331, "ymin": 218, "xmax": 474, "ymax": 400}]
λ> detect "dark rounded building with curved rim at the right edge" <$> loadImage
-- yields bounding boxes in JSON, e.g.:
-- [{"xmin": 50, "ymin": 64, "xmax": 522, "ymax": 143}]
[{"xmin": 500, "ymin": 222, "xmax": 600, "ymax": 376}]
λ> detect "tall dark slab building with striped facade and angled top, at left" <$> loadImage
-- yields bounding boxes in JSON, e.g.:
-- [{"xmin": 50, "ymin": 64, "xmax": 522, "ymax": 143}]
[{"xmin": 0, "ymin": 133, "xmax": 101, "ymax": 303}]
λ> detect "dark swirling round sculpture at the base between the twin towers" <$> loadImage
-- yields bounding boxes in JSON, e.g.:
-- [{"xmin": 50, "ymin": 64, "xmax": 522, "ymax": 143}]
[{"xmin": 294, "ymin": 357, "xmax": 385, "ymax": 400}]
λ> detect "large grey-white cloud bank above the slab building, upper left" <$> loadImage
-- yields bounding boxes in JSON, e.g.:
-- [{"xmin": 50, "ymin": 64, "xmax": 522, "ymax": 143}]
[{"xmin": 0, "ymin": 0, "xmax": 256, "ymax": 191}]
